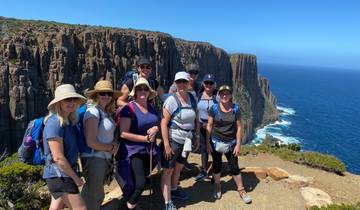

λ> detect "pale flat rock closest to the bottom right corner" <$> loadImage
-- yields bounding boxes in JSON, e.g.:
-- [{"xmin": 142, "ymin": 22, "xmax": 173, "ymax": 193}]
[{"xmin": 300, "ymin": 187, "xmax": 333, "ymax": 209}]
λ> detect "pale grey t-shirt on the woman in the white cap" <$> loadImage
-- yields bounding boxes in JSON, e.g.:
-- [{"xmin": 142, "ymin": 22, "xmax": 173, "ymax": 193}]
[{"xmin": 163, "ymin": 95, "xmax": 196, "ymax": 144}]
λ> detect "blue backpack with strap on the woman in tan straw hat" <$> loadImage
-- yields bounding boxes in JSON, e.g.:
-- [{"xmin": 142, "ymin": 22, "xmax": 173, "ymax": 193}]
[{"xmin": 75, "ymin": 104, "xmax": 103, "ymax": 153}]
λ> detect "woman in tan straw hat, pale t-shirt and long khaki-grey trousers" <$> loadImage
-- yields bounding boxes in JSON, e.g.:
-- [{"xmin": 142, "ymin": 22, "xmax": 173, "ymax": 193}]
[{"xmin": 81, "ymin": 80, "xmax": 121, "ymax": 210}]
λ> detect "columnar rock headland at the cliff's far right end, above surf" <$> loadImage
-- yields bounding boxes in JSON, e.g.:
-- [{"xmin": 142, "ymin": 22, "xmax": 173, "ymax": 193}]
[{"xmin": 230, "ymin": 54, "xmax": 279, "ymax": 141}]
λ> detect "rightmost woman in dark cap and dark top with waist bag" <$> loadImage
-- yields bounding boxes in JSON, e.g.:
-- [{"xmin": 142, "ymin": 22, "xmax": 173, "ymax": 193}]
[{"xmin": 206, "ymin": 85, "xmax": 251, "ymax": 203}]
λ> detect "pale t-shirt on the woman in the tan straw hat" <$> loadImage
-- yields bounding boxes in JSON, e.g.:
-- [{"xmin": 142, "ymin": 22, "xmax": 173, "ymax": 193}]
[{"xmin": 81, "ymin": 105, "xmax": 115, "ymax": 159}]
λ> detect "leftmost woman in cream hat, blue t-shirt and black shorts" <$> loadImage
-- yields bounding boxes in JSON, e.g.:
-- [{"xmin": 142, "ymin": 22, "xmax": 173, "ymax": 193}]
[{"xmin": 43, "ymin": 84, "xmax": 86, "ymax": 209}]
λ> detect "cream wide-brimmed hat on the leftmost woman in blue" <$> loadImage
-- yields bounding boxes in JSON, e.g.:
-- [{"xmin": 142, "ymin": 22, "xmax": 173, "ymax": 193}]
[{"xmin": 48, "ymin": 84, "xmax": 86, "ymax": 110}]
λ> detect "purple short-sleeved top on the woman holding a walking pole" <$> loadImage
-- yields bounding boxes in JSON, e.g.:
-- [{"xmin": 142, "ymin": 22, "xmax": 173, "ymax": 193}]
[{"xmin": 119, "ymin": 102, "xmax": 160, "ymax": 159}]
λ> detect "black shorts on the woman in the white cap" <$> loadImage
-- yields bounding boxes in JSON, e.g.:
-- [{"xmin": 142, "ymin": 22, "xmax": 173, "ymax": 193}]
[{"xmin": 160, "ymin": 140, "xmax": 186, "ymax": 168}]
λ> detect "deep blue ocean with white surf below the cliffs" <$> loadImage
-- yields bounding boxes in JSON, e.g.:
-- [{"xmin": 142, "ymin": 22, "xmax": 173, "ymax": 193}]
[{"xmin": 253, "ymin": 64, "xmax": 360, "ymax": 175}]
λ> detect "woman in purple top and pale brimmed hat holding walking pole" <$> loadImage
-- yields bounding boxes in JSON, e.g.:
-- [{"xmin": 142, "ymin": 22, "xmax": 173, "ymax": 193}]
[{"xmin": 118, "ymin": 77, "xmax": 160, "ymax": 209}]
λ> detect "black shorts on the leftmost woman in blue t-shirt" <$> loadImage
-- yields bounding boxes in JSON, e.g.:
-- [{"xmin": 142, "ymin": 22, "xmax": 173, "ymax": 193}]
[{"xmin": 46, "ymin": 177, "xmax": 79, "ymax": 199}]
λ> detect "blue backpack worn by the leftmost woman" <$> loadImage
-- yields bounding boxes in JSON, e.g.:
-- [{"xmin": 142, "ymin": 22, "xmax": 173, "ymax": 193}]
[{"xmin": 18, "ymin": 117, "xmax": 45, "ymax": 165}]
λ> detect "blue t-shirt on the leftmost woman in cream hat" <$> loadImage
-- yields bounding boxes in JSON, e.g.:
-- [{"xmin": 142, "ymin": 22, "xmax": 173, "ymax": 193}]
[{"xmin": 43, "ymin": 115, "xmax": 79, "ymax": 179}]
